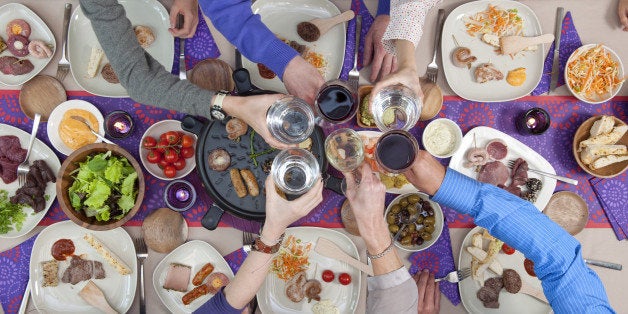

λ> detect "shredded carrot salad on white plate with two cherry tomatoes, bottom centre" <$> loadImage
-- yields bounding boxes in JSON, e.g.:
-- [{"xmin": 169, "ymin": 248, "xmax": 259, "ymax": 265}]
[{"xmin": 270, "ymin": 235, "xmax": 312, "ymax": 281}]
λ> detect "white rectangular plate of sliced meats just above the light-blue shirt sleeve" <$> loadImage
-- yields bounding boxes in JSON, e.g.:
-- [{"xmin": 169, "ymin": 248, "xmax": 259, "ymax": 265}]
[{"xmin": 449, "ymin": 126, "xmax": 556, "ymax": 211}]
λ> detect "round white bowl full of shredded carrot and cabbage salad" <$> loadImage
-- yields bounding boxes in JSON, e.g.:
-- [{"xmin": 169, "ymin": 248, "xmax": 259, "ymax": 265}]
[{"xmin": 565, "ymin": 44, "xmax": 626, "ymax": 104}]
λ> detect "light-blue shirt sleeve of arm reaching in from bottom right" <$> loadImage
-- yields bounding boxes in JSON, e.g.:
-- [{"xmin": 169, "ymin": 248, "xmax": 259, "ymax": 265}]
[{"xmin": 433, "ymin": 169, "xmax": 614, "ymax": 313}]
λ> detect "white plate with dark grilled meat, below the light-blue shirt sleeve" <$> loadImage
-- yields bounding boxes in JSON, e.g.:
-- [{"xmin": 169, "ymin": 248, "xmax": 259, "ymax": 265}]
[{"xmin": 458, "ymin": 227, "xmax": 552, "ymax": 314}]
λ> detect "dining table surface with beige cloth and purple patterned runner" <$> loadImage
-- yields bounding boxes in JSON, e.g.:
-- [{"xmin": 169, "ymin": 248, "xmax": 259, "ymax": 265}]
[{"xmin": 0, "ymin": 0, "xmax": 628, "ymax": 313}]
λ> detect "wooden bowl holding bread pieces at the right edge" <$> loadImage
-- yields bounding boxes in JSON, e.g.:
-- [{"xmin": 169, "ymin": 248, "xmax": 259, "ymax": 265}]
[{"xmin": 573, "ymin": 116, "xmax": 628, "ymax": 178}]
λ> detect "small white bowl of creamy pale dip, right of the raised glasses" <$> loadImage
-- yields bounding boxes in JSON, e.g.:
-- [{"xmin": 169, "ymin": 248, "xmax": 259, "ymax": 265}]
[{"xmin": 421, "ymin": 118, "xmax": 462, "ymax": 158}]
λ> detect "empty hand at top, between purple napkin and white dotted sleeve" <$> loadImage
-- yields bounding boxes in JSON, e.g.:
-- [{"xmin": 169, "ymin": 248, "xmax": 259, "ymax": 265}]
[{"xmin": 364, "ymin": 15, "xmax": 397, "ymax": 82}]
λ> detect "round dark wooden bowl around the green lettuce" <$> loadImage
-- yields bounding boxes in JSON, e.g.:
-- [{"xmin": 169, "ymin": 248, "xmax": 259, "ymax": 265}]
[{"xmin": 57, "ymin": 143, "xmax": 146, "ymax": 231}]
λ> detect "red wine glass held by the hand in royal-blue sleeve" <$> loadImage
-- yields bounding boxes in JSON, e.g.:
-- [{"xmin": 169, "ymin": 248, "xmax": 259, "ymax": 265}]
[{"xmin": 316, "ymin": 85, "xmax": 357, "ymax": 122}]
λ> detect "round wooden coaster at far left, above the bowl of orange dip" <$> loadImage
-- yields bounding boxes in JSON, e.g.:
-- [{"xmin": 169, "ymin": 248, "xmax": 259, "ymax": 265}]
[{"xmin": 19, "ymin": 75, "xmax": 68, "ymax": 122}]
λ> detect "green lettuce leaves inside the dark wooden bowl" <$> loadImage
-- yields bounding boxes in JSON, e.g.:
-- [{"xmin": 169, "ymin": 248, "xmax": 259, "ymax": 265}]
[{"xmin": 68, "ymin": 151, "xmax": 138, "ymax": 221}]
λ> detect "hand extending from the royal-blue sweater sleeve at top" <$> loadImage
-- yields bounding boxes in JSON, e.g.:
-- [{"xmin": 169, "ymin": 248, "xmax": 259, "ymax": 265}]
[{"xmin": 283, "ymin": 56, "xmax": 325, "ymax": 105}]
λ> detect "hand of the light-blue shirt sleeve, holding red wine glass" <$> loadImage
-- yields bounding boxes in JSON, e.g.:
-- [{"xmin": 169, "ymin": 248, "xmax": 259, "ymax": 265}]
[{"xmin": 403, "ymin": 150, "xmax": 445, "ymax": 195}]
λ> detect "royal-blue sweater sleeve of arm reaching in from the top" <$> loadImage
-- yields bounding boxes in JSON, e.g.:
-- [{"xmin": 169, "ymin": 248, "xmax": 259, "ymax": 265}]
[{"xmin": 199, "ymin": 0, "xmax": 298, "ymax": 79}]
